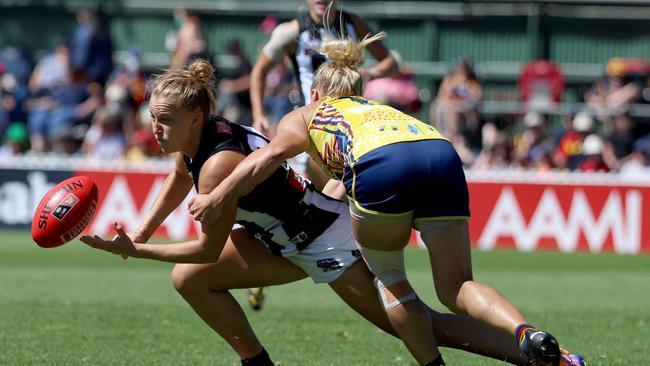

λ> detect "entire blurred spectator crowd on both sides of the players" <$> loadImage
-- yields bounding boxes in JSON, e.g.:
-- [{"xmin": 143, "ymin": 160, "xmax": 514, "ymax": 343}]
[{"xmin": 0, "ymin": 9, "xmax": 650, "ymax": 174}]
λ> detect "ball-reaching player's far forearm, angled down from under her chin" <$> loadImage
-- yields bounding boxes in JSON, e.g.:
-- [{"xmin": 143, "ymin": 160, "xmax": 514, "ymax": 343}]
[{"xmin": 129, "ymin": 152, "xmax": 194, "ymax": 243}]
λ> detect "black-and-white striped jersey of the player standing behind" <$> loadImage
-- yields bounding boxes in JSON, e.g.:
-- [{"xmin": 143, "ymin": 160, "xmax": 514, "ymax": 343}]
[{"xmin": 291, "ymin": 12, "xmax": 357, "ymax": 105}]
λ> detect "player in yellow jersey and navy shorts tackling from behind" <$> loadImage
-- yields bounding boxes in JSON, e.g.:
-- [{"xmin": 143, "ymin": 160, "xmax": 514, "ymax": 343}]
[{"xmin": 190, "ymin": 33, "xmax": 584, "ymax": 366}]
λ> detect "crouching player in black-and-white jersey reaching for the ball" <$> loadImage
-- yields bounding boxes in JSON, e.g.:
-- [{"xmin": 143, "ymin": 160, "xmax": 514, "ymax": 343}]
[{"xmin": 82, "ymin": 60, "xmax": 560, "ymax": 365}]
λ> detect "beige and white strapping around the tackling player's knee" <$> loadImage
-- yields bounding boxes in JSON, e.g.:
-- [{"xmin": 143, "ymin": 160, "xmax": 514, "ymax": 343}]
[{"xmin": 360, "ymin": 246, "xmax": 417, "ymax": 311}]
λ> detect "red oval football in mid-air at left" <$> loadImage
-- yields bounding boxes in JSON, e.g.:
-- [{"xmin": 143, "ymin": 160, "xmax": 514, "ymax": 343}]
[{"xmin": 32, "ymin": 176, "xmax": 97, "ymax": 248}]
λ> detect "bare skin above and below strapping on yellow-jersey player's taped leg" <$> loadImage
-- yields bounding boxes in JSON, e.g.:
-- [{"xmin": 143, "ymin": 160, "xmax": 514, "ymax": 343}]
[{"xmin": 352, "ymin": 218, "xmax": 440, "ymax": 365}]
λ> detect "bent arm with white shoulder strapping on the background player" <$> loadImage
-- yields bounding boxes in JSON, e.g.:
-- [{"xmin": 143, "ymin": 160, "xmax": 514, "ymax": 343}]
[{"xmin": 250, "ymin": 20, "xmax": 298, "ymax": 131}]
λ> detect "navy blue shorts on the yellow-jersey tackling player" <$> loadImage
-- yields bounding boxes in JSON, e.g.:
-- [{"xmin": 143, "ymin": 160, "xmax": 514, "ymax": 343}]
[{"xmin": 343, "ymin": 139, "xmax": 469, "ymax": 220}]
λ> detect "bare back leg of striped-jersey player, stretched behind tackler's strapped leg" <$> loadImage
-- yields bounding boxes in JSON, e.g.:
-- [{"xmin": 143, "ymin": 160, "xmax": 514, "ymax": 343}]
[{"xmin": 330, "ymin": 261, "xmax": 528, "ymax": 365}]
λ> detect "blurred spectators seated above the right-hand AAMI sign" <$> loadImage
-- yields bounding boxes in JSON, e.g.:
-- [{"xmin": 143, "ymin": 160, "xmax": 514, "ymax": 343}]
[{"xmin": 429, "ymin": 58, "xmax": 650, "ymax": 174}]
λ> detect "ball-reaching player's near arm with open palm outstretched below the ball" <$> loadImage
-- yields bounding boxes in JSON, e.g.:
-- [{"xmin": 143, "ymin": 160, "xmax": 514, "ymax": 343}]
[{"xmin": 82, "ymin": 151, "xmax": 244, "ymax": 263}]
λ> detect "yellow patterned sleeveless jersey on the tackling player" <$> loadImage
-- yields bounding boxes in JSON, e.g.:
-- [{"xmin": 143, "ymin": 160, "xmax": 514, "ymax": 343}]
[{"xmin": 307, "ymin": 97, "xmax": 445, "ymax": 179}]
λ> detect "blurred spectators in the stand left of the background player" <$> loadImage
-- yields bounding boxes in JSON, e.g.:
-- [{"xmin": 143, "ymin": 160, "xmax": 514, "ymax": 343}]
[{"xmin": 0, "ymin": 9, "xmax": 297, "ymax": 161}]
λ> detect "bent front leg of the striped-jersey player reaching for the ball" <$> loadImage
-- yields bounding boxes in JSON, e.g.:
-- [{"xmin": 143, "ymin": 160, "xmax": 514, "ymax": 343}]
[{"xmin": 172, "ymin": 230, "xmax": 307, "ymax": 359}]
